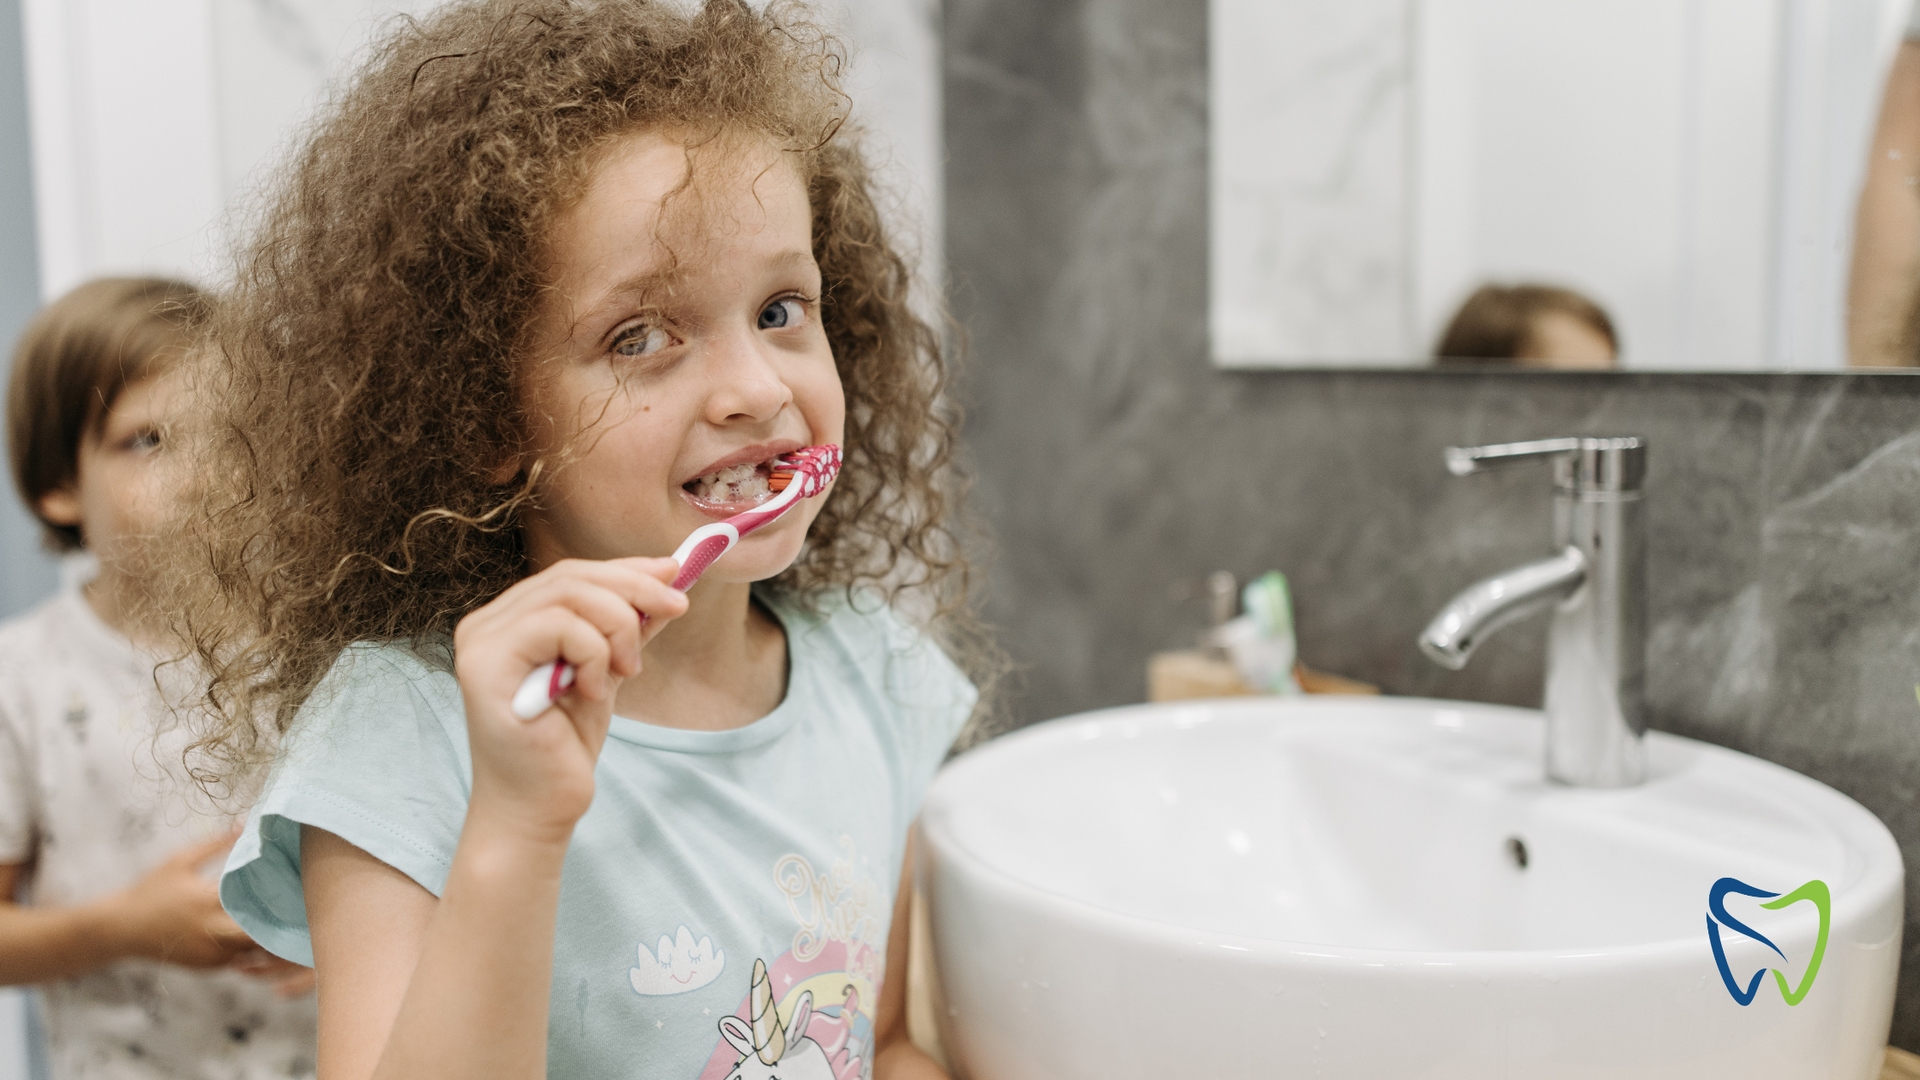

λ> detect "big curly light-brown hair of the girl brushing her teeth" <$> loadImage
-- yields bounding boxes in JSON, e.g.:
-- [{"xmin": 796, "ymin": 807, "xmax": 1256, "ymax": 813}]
[{"xmin": 156, "ymin": 0, "xmax": 985, "ymax": 786}]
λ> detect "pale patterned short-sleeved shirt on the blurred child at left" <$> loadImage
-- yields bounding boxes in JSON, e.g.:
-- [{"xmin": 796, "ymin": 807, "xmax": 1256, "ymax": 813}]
[{"xmin": 0, "ymin": 575, "xmax": 315, "ymax": 1080}]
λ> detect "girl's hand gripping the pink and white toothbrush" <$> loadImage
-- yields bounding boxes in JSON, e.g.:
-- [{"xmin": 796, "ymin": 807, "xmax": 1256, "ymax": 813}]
[{"xmin": 453, "ymin": 559, "xmax": 687, "ymax": 844}]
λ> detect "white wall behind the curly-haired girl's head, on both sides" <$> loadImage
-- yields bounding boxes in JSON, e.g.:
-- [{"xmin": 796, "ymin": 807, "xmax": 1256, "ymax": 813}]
[{"xmin": 25, "ymin": 0, "xmax": 941, "ymax": 296}]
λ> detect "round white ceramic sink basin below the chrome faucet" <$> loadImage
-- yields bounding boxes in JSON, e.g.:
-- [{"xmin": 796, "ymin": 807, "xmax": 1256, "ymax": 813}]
[{"xmin": 920, "ymin": 698, "xmax": 1903, "ymax": 1080}]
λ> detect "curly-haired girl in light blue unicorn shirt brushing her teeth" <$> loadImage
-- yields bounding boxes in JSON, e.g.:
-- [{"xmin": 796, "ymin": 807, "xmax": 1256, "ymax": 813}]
[{"xmin": 169, "ymin": 0, "xmax": 975, "ymax": 1080}]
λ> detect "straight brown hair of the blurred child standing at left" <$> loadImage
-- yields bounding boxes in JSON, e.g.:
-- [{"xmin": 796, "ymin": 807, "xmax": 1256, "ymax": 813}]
[{"xmin": 6, "ymin": 277, "xmax": 207, "ymax": 552}]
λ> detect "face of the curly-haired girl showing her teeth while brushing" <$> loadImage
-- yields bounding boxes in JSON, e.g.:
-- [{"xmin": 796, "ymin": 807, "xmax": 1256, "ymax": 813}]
[{"xmin": 526, "ymin": 133, "xmax": 847, "ymax": 582}]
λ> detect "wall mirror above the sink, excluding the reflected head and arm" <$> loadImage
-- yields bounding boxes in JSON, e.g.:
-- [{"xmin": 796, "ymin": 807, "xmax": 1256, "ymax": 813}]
[{"xmin": 1208, "ymin": 0, "xmax": 1912, "ymax": 369}]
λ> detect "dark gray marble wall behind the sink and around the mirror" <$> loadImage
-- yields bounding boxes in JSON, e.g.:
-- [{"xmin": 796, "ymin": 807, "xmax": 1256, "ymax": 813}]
[{"xmin": 947, "ymin": 0, "xmax": 1920, "ymax": 1049}]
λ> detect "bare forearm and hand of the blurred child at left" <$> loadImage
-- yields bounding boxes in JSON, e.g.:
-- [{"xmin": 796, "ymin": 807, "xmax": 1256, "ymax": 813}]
[{"xmin": 0, "ymin": 836, "xmax": 255, "ymax": 986}]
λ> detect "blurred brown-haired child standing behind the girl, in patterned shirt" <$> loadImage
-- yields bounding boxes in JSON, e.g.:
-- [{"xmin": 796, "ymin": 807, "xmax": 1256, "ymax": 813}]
[{"xmin": 0, "ymin": 279, "xmax": 315, "ymax": 1080}]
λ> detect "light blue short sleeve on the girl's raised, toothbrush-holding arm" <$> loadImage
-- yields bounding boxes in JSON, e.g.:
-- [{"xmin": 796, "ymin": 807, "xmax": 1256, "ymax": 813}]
[{"xmin": 221, "ymin": 646, "xmax": 472, "ymax": 965}]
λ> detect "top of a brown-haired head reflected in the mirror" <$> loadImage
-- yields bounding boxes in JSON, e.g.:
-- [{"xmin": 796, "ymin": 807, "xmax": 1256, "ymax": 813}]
[{"xmin": 1434, "ymin": 284, "xmax": 1620, "ymax": 371}]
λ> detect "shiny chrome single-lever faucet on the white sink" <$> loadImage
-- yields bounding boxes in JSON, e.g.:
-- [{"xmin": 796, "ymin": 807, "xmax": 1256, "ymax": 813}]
[{"xmin": 1421, "ymin": 438, "xmax": 1647, "ymax": 788}]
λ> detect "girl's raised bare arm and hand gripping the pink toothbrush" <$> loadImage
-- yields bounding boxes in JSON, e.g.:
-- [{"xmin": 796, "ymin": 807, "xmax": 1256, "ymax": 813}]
[{"xmin": 300, "ymin": 559, "xmax": 685, "ymax": 1080}]
